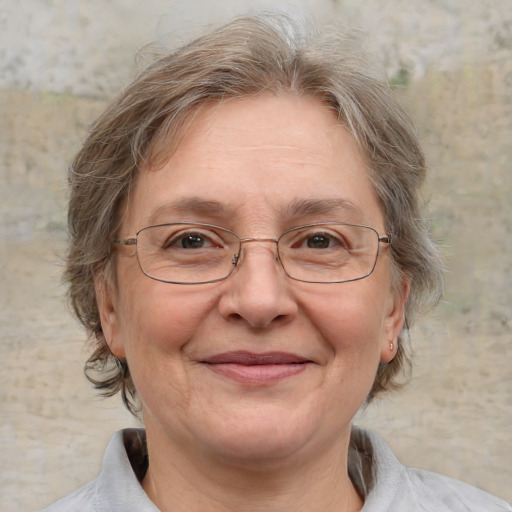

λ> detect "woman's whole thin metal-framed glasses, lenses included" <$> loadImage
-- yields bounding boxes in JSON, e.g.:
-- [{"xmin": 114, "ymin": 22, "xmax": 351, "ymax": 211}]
[{"xmin": 113, "ymin": 222, "xmax": 391, "ymax": 284}]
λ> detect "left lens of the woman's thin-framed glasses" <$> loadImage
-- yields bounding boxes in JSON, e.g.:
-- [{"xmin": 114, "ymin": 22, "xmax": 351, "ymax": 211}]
[{"xmin": 137, "ymin": 223, "xmax": 240, "ymax": 284}]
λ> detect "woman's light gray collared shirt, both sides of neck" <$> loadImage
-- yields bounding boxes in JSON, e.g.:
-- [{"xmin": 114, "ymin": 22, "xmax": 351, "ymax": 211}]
[{"xmin": 41, "ymin": 428, "xmax": 512, "ymax": 512}]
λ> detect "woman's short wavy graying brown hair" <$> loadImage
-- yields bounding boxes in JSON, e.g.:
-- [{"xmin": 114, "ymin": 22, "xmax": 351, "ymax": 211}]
[{"xmin": 64, "ymin": 15, "xmax": 443, "ymax": 414}]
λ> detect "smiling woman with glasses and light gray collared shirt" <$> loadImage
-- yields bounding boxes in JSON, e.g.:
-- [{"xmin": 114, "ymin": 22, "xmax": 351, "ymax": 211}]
[{"xmin": 42, "ymin": 17, "xmax": 512, "ymax": 512}]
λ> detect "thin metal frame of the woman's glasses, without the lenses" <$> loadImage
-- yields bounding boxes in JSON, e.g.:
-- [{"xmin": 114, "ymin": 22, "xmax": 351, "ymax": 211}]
[{"xmin": 111, "ymin": 221, "xmax": 392, "ymax": 285}]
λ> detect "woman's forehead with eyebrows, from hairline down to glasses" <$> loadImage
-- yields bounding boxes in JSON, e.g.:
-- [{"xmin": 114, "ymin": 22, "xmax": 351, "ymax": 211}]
[{"xmin": 122, "ymin": 94, "xmax": 381, "ymax": 232}]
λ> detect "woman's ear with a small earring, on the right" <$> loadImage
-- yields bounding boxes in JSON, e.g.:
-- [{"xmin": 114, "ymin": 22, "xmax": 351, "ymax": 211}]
[{"xmin": 380, "ymin": 276, "xmax": 411, "ymax": 363}]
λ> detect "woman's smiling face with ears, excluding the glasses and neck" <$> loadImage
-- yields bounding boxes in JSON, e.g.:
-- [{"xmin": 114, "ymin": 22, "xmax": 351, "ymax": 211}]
[{"xmin": 98, "ymin": 95, "xmax": 407, "ymax": 463}]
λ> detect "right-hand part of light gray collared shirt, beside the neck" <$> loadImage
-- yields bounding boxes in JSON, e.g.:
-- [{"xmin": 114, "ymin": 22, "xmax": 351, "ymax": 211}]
[{"xmin": 349, "ymin": 428, "xmax": 512, "ymax": 512}]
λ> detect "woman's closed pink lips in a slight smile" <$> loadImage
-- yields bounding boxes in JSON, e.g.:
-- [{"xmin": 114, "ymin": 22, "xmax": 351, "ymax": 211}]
[{"xmin": 202, "ymin": 351, "xmax": 311, "ymax": 385}]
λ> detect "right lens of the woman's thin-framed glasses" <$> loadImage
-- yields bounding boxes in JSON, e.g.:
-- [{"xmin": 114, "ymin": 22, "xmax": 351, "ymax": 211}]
[{"xmin": 278, "ymin": 223, "xmax": 379, "ymax": 283}]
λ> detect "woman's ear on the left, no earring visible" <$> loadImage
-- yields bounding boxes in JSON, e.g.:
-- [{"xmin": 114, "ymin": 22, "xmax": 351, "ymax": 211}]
[{"xmin": 94, "ymin": 271, "xmax": 126, "ymax": 357}]
